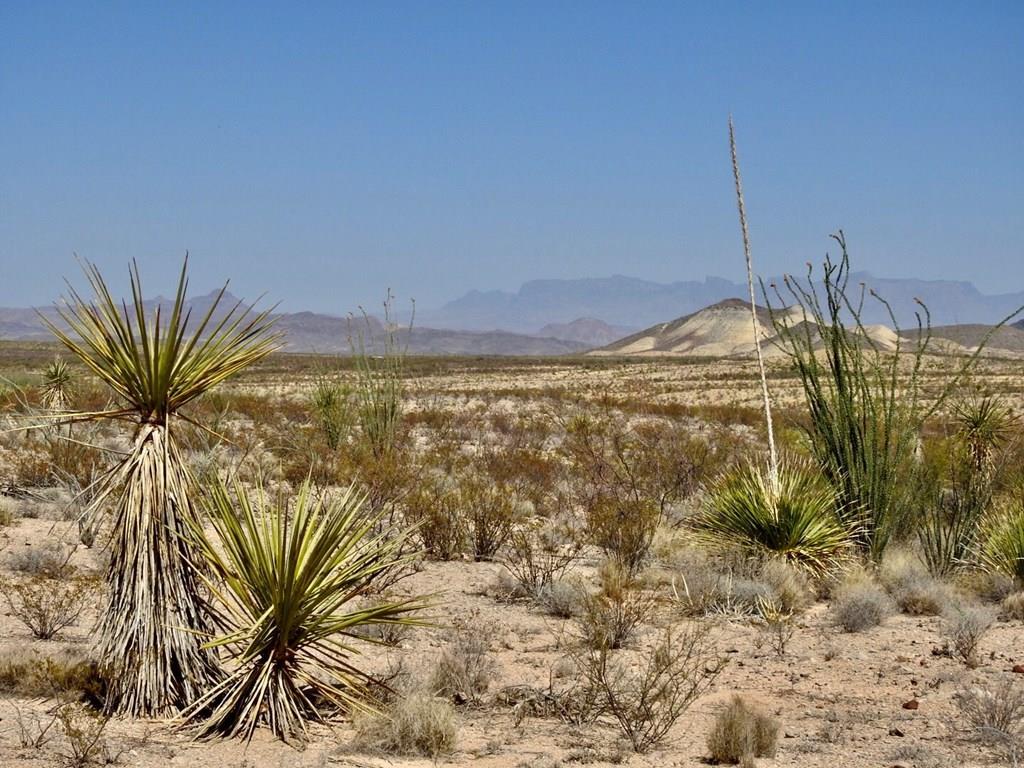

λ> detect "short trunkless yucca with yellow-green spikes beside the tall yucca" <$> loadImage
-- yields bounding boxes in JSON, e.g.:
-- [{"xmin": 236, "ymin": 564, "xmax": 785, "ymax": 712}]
[{"xmin": 183, "ymin": 481, "xmax": 426, "ymax": 740}]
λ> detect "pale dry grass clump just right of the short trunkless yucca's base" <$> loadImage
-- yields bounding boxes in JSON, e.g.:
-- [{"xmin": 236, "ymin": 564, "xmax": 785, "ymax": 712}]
[{"xmin": 355, "ymin": 690, "xmax": 458, "ymax": 759}]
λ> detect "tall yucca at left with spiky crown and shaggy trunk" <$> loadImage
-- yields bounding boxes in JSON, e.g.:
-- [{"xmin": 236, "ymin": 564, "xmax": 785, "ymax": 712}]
[{"xmin": 44, "ymin": 258, "xmax": 279, "ymax": 716}]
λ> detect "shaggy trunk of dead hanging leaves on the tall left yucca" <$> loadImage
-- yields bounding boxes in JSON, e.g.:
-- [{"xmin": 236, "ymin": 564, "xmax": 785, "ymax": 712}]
[{"xmin": 99, "ymin": 423, "xmax": 217, "ymax": 716}]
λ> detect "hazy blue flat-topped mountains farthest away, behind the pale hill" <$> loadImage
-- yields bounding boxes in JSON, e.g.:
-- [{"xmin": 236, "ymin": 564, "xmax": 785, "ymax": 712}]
[{"xmin": 420, "ymin": 272, "xmax": 1024, "ymax": 333}]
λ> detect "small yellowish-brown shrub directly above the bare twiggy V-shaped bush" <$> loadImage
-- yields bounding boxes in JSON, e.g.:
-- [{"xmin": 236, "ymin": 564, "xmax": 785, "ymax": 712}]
[{"xmin": 575, "ymin": 561, "xmax": 655, "ymax": 649}]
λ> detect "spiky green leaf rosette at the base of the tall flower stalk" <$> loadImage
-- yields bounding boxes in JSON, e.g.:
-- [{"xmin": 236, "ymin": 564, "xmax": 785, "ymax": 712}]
[{"xmin": 692, "ymin": 464, "xmax": 852, "ymax": 575}]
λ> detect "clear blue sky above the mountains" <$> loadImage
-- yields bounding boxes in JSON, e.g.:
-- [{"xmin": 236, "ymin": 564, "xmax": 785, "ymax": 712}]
[{"xmin": 0, "ymin": 0, "xmax": 1024, "ymax": 312}]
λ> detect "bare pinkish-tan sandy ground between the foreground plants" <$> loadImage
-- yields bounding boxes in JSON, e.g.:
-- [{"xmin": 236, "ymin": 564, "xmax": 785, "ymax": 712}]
[{"xmin": 0, "ymin": 512, "xmax": 1024, "ymax": 768}]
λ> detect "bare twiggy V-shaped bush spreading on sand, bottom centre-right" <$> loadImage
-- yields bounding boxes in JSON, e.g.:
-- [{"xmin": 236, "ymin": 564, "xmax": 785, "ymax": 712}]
[{"xmin": 581, "ymin": 627, "xmax": 725, "ymax": 753}]
